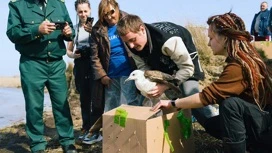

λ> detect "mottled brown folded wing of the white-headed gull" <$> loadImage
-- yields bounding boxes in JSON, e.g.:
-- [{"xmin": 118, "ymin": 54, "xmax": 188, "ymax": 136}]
[{"xmin": 144, "ymin": 70, "xmax": 181, "ymax": 94}]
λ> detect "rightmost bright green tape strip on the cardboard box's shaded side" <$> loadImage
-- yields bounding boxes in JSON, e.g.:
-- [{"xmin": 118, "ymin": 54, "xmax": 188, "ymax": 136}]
[{"xmin": 177, "ymin": 110, "xmax": 192, "ymax": 139}]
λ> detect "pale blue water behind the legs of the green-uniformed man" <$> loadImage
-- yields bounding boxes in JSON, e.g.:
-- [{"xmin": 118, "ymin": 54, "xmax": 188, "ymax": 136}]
[{"xmin": 0, "ymin": 88, "xmax": 51, "ymax": 129}]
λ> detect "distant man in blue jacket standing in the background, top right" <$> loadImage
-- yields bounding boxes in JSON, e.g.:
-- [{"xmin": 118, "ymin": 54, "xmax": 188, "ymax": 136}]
[{"xmin": 250, "ymin": 2, "xmax": 271, "ymax": 41}]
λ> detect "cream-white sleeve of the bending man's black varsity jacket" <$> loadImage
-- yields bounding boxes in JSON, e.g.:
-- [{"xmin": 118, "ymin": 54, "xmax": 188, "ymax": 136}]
[{"xmin": 162, "ymin": 36, "xmax": 194, "ymax": 83}]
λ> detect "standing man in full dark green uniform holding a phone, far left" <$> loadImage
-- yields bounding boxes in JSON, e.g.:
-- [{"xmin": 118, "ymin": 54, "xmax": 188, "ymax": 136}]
[{"xmin": 6, "ymin": 0, "xmax": 77, "ymax": 153}]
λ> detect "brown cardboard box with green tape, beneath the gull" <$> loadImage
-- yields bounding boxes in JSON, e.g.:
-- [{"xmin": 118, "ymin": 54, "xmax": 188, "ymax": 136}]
[{"xmin": 103, "ymin": 105, "xmax": 194, "ymax": 153}]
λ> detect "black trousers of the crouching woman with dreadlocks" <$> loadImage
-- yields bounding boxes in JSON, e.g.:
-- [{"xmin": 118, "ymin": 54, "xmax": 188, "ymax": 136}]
[{"xmin": 205, "ymin": 97, "xmax": 272, "ymax": 151}]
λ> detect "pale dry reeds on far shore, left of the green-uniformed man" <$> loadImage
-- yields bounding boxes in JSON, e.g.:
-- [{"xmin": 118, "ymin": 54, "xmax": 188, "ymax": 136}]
[{"xmin": 0, "ymin": 76, "xmax": 21, "ymax": 88}]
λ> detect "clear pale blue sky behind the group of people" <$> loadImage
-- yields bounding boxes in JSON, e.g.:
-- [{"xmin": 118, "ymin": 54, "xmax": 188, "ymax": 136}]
[{"xmin": 0, "ymin": 0, "xmax": 272, "ymax": 76}]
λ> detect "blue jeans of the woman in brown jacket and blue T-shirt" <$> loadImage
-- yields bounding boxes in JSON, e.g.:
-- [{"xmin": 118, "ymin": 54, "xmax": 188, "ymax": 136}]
[{"xmin": 104, "ymin": 76, "xmax": 142, "ymax": 112}]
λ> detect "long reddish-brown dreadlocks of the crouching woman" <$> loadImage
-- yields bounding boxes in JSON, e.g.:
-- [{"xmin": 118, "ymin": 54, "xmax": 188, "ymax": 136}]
[{"xmin": 207, "ymin": 12, "xmax": 272, "ymax": 110}]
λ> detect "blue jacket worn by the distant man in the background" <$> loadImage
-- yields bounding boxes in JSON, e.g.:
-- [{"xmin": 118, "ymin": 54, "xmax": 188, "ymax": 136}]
[{"xmin": 250, "ymin": 9, "xmax": 271, "ymax": 37}]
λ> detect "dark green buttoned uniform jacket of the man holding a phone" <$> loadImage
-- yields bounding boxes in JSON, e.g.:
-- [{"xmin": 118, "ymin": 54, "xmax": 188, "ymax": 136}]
[{"xmin": 6, "ymin": 0, "xmax": 75, "ymax": 58}]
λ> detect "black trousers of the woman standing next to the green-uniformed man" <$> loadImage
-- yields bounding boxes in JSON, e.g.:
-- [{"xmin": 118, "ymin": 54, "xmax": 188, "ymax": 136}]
[{"xmin": 74, "ymin": 58, "xmax": 99, "ymax": 130}]
